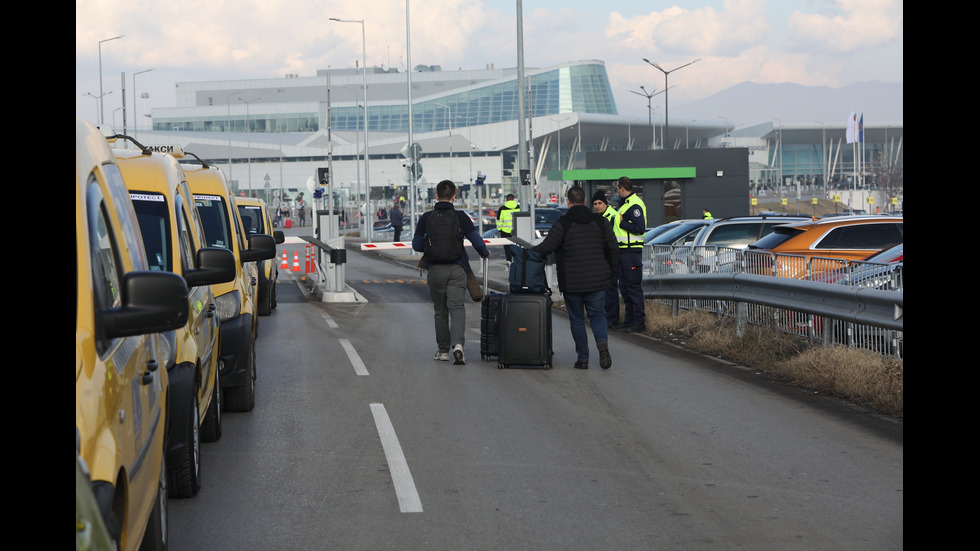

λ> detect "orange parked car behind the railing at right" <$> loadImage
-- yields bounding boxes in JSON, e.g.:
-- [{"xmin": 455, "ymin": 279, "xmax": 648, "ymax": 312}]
[{"xmin": 749, "ymin": 216, "xmax": 904, "ymax": 278}]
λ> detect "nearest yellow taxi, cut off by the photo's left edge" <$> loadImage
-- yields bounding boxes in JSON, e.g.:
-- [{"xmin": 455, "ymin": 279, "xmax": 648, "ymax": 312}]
[{"xmin": 75, "ymin": 119, "xmax": 188, "ymax": 551}]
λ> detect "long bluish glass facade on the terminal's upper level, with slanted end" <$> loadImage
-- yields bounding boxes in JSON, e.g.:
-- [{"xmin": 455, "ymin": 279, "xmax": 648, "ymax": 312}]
[{"xmin": 153, "ymin": 63, "xmax": 617, "ymax": 132}]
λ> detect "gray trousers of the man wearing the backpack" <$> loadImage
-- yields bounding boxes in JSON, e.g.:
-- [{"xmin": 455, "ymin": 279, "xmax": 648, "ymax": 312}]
[{"xmin": 428, "ymin": 264, "xmax": 466, "ymax": 352}]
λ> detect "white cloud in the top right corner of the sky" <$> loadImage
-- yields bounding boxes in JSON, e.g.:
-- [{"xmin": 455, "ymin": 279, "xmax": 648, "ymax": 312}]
[{"xmin": 783, "ymin": 0, "xmax": 904, "ymax": 53}]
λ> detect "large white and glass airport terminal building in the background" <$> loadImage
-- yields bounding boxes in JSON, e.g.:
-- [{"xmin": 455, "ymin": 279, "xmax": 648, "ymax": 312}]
[{"xmin": 138, "ymin": 60, "xmax": 903, "ymax": 218}]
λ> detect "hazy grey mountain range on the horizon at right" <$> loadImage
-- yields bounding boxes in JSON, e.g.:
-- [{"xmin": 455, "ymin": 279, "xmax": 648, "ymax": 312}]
[{"xmin": 670, "ymin": 81, "xmax": 903, "ymax": 128}]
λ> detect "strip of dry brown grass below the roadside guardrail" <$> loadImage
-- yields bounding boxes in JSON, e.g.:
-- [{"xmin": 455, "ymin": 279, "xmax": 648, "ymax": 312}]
[{"xmin": 646, "ymin": 301, "xmax": 904, "ymax": 417}]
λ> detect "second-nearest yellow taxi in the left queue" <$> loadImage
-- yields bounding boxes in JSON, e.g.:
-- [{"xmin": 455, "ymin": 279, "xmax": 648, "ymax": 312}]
[{"xmin": 113, "ymin": 137, "xmax": 235, "ymax": 497}]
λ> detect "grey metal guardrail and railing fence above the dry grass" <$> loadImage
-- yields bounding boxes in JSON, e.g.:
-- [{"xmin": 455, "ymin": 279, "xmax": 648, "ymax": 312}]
[{"xmin": 644, "ymin": 247, "xmax": 904, "ymax": 358}]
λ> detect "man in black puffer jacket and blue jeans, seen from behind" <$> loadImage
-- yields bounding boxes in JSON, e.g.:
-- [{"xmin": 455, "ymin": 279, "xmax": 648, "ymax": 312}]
[{"xmin": 532, "ymin": 187, "xmax": 619, "ymax": 369}]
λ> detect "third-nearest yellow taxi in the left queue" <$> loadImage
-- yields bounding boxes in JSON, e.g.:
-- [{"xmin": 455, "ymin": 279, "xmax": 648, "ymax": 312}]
[{"xmin": 183, "ymin": 156, "xmax": 276, "ymax": 411}]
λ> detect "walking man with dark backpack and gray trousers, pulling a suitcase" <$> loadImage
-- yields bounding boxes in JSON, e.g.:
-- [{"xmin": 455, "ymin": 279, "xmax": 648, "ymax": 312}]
[{"xmin": 412, "ymin": 180, "xmax": 490, "ymax": 365}]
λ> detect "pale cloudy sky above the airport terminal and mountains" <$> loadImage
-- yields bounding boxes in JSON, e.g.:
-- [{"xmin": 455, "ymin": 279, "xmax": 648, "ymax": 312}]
[{"xmin": 75, "ymin": 0, "xmax": 904, "ymax": 123}]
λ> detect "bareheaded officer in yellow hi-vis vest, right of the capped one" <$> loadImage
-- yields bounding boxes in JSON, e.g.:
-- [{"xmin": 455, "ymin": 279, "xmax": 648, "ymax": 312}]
[{"xmin": 613, "ymin": 176, "xmax": 647, "ymax": 333}]
